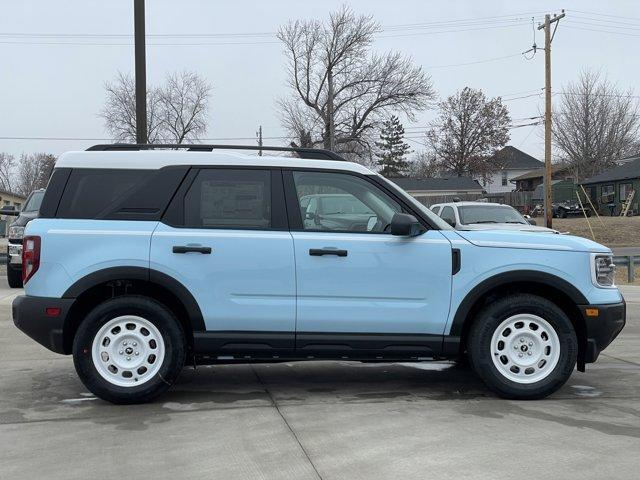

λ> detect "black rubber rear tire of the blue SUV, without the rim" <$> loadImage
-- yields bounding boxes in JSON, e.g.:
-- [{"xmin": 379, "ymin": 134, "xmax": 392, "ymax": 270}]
[{"xmin": 73, "ymin": 296, "xmax": 185, "ymax": 404}]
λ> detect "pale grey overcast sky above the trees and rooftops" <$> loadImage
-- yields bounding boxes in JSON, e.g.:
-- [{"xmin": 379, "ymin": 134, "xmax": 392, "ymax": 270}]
[{"xmin": 0, "ymin": 0, "xmax": 640, "ymax": 158}]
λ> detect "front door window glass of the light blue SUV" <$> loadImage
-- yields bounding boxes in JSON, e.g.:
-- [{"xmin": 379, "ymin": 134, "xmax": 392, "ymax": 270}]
[{"xmin": 293, "ymin": 172, "xmax": 402, "ymax": 233}]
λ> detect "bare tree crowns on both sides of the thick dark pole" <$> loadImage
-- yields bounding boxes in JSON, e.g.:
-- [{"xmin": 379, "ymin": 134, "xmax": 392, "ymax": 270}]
[{"xmin": 99, "ymin": 72, "xmax": 211, "ymax": 143}]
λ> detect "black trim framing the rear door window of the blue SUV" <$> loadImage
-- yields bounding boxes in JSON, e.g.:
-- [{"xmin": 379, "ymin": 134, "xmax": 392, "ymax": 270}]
[{"xmin": 160, "ymin": 165, "xmax": 289, "ymax": 232}]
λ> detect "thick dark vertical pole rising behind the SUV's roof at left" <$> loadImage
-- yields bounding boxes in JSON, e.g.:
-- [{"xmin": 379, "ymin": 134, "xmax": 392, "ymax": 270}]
[{"xmin": 133, "ymin": 0, "xmax": 148, "ymax": 143}]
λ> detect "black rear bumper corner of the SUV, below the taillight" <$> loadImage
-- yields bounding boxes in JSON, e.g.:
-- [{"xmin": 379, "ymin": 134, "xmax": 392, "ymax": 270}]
[{"xmin": 11, "ymin": 295, "xmax": 74, "ymax": 353}]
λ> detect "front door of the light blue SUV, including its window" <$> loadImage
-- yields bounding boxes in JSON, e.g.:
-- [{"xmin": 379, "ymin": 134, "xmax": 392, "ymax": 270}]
[{"xmin": 286, "ymin": 170, "xmax": 452, "ymax": 355}]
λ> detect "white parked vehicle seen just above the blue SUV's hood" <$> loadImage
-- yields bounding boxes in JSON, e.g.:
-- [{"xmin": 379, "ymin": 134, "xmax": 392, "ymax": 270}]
[{"xmin": 431, "ymin": 202, "xmax": 558, "ymax": 233}]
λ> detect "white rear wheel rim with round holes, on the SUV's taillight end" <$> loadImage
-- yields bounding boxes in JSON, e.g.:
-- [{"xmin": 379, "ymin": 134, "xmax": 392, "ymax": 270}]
[{"xmin": 91, "ymin": 315, "xmax": 165, "ymax": 387}]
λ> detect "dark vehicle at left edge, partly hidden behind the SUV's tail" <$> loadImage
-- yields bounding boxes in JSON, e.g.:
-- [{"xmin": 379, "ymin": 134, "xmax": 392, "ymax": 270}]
[{"xmin": 0, "ymin": 189, "xmax": 44, "ymax": 288}]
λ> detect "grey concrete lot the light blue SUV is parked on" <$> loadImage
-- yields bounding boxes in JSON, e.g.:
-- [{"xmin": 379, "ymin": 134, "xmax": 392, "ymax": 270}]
[{"xmin": 0, "ymin": 280, "xmax": 640, "ymax": 480}]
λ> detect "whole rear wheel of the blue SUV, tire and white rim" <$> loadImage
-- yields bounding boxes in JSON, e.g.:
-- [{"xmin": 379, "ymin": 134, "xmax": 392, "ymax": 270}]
[{"xmin": 73, "ymin": 296, "xmax": 185, "ymax": 404}]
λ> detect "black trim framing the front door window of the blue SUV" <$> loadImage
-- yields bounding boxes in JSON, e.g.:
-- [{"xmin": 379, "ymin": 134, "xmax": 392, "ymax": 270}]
[{"xmin": 282, "ymin": 167, "xmax": 440, "ymax": 235}]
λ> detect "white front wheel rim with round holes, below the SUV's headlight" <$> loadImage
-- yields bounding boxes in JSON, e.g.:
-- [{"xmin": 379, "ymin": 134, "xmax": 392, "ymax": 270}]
[{"xmin": 491, "ymin": 313, "xmax": 560, "ymax": 384}]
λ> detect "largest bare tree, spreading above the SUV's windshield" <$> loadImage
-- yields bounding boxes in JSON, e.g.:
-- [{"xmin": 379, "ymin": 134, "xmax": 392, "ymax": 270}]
[{"xmin": 278, "ymin": 7, "xmax": 435, "ymax": 158}]
